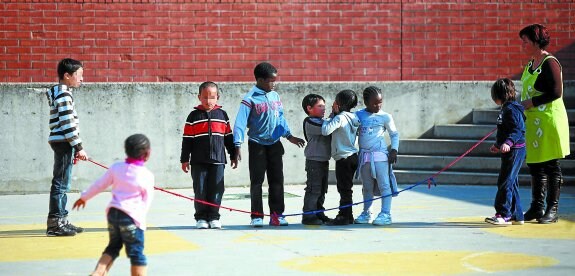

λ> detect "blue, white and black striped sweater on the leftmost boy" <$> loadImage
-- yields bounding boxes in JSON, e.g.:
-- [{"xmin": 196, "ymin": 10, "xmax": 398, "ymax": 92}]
[{"xmin": 46, "ymin": 84, "xmax": 82, "ymax": 151}]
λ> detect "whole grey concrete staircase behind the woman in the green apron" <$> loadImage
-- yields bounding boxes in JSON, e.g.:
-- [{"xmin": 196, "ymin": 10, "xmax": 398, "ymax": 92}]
[{"xmin": 394, "ymin": 93, "xmax": 575, "ymax": 185}]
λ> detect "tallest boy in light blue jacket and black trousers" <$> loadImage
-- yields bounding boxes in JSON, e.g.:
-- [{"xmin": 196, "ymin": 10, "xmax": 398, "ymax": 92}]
[{"xmin": 234, "ymin": 62, "xmax": 305, "ymax": 227}]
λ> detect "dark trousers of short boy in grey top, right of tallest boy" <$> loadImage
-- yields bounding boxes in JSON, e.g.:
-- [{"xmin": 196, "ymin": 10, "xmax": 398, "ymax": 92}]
[{"xmin": 303, "ymin": 159, "xmax": 329, "ymax": 219}]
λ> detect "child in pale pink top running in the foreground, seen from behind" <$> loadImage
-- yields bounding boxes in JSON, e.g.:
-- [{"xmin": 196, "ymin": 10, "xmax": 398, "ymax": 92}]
[{"xmin": 72, "ymin": 134, "xmax": 154, "ymax": 275}]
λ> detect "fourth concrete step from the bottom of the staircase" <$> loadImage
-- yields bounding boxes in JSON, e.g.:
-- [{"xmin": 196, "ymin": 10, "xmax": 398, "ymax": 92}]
[{"xmin": 433, "ymin": 124, "xmax": 575, "ymax": 142}]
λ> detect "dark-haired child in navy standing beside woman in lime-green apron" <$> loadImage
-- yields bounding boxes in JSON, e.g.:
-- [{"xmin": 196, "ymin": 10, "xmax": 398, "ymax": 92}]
[{"xmin": 485, "ymin": 78, "xmax": 525, "ymax": 225}]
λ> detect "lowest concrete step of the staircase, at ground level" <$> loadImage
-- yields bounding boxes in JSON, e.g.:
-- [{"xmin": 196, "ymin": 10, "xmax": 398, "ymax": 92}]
[{"xmin": 395, "ymin": 170, "xmax": 575, "ymax": 186}]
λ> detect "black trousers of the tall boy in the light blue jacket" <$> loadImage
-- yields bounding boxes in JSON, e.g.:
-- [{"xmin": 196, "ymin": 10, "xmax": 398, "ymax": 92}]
[{"xmin": 248, "ymin": 141, "xmax": 285, "ymax": 218}]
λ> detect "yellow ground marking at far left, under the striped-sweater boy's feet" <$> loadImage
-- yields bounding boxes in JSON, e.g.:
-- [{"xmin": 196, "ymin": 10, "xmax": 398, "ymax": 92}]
[{"xmin": 0, "ymin": 222, "xmax": 199, "ymax": 262}]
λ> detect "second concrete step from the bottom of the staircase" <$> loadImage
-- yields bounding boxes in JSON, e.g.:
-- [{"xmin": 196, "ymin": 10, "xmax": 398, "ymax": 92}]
[{"xmin": 394, "ymin": 154, "xmax": 575, "ymax": 172}]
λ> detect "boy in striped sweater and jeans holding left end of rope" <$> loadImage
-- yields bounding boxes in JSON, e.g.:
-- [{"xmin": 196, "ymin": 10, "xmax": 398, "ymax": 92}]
[{"xmin": 46, "ymin": 58, "xmax": 88, "ymax": 237}]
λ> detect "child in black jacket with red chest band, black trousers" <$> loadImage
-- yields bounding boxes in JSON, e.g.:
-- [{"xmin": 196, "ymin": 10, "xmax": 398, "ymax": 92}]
[{"xmin": 180, "ymin": 81, "xmax": 238, "ymax": 229}]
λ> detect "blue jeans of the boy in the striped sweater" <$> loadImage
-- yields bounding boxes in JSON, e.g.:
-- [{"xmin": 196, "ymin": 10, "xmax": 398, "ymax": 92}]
[{"xmin": 48, "ymin": 143, "xmax": 74, "ymax": 218}]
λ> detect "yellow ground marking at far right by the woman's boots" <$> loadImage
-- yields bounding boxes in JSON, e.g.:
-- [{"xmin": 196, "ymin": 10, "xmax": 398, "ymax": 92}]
[{"xmin": 448, "ymin": 216, "xmax": 575, "ymax": 240}]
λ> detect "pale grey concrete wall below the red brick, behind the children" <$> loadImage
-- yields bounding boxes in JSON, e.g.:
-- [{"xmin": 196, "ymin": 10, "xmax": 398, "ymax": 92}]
[{"xmin": 0, "ymin": 82, "xmax": 524, "ymax": 193}]
